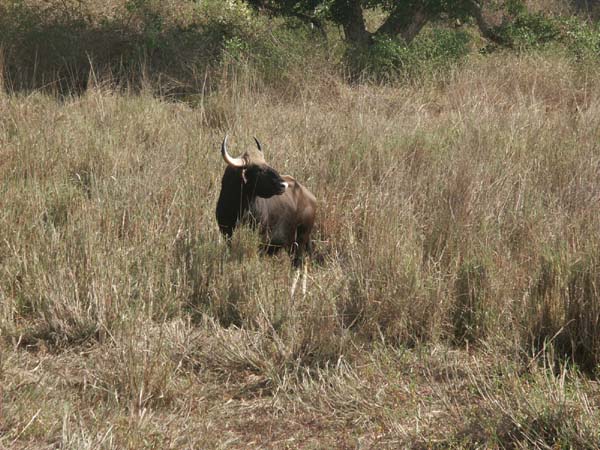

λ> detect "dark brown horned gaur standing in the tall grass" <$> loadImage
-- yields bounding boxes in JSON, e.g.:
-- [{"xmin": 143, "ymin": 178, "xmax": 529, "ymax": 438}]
[{"xmin": 216, "ymin": 135, "xmax": 317, "ymax": 268}]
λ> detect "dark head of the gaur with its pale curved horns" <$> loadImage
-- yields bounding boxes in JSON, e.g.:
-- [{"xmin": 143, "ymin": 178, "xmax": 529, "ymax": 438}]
[{"xmin": 221, "ymin": 135, "xmax": 288, "ymax": 198}]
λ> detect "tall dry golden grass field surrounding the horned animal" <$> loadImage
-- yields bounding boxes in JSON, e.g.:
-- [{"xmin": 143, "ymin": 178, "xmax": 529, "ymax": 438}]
[{"xmin": 0, "ymin": 51, "xmax": 600, "ymax": 447}]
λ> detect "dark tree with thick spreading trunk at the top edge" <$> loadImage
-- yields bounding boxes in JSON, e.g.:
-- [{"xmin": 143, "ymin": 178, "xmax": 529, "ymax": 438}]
[{"xmin": 247, "ymin": 0, "xmax": 506, "ymax": 47}]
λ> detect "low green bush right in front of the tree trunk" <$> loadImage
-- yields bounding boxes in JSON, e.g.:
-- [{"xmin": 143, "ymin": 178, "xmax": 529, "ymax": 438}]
[{"xmin": 347, "ymin": 28, "xmax": 471, "ymax": 81}]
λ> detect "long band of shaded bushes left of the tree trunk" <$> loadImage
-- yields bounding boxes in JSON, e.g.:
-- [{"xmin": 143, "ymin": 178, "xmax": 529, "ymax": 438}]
[{"xmin": 0, "ymin": 0, "xmax": 323, "ymax": 95}]
